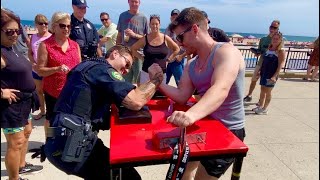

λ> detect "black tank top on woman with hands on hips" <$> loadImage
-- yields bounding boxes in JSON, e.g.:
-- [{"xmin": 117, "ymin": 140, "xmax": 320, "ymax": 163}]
[{"xmin": 142, "ymin": 35, "xmax": 169, "ymax": 72}]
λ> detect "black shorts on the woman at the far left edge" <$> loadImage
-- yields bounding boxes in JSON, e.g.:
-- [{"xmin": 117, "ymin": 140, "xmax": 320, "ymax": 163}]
[{"xmin": 0, "ymin": 98, "xmax": 32, "ymax": 128}]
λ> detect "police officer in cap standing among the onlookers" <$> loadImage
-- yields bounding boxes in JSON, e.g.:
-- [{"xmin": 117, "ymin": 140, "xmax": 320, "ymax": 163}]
[{"xmin": 70, "ymin": 0, "xmax": 102, "ymax": 60}]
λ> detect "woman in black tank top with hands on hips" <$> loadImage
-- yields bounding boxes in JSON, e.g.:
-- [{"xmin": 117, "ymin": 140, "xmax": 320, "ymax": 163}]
[{"xmin": 131, "ymin": 15, "xmax": 180, "ymax": 84}]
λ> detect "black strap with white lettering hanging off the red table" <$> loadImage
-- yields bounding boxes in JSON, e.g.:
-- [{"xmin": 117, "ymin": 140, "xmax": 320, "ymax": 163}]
[{"xmin": 166, "ymin": 128, "xmax": 190, "ymax": 180}]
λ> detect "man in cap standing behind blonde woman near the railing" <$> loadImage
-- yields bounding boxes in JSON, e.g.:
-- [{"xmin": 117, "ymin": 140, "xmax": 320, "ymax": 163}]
[{"xmin": 243, "ymin": 20, "xmax": 280, "ymax": 102}]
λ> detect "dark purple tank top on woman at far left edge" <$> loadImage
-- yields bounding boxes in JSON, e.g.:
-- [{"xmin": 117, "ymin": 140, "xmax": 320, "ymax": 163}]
[{"xmin": 0, "ymin": 46, "xmax": 36, "ymax": 93}]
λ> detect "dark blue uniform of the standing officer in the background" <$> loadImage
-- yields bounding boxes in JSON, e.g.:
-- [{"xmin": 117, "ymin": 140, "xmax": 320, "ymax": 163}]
[{"xmin": 70, "ymin": 14, "xmax": 99, "ymax": 59}]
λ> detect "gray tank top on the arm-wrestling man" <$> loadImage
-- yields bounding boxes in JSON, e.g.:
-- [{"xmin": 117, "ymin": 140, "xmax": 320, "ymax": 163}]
[{"xmin": 189, "ymin": 43, "xmax": 245, "ymax": 130}]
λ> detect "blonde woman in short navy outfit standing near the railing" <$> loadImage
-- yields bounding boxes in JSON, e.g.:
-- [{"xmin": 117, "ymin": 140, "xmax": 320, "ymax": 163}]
[{"xmin": 253, "ymin": 32, "xmax": 285, "ymax": 114}]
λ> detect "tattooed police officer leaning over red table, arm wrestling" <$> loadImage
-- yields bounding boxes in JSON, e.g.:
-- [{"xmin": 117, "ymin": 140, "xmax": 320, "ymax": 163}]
[{"xmin": 43, "ymin": 45, "xmax": 163, "ymax": 180}]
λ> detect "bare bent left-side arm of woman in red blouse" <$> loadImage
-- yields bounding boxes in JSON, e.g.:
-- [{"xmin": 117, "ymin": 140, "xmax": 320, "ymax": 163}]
[{"xmin": 37, "ymin": 42, "xmax": 63, "ymax": 77}]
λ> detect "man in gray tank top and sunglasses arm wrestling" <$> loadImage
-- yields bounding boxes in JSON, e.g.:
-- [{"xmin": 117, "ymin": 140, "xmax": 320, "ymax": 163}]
[{"xmin": 159, "ymin": 8, "xmax": 245, "ymax": 180}]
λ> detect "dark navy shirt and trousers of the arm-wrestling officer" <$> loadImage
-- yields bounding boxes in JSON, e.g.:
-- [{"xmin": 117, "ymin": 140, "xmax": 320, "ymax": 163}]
[{"xmin": 44, "ymin": 59, "xmax": 141, "ymax": 179}]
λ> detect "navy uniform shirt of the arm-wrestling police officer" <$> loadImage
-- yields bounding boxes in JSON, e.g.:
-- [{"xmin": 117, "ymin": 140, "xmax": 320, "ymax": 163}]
[{"xmin": 53, "ymin": 59, "xmax": 136, "ymax": 129}]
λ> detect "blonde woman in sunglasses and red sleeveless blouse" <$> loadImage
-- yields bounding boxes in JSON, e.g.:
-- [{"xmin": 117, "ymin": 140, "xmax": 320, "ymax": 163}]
[{"xmin": 37, "ymin": 12, "xmax": 81, "ymax": 138}]
